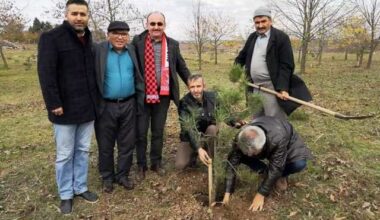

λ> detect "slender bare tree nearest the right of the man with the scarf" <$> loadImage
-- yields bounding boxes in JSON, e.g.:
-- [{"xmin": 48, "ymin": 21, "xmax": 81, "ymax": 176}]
[{"xmin": 187, "ymin": 0, "xmax": 209, "ymax": 70}]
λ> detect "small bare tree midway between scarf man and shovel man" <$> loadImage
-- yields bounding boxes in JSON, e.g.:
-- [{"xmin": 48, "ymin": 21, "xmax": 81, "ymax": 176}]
[{"xmin": 208, "ymin": 13, "xmax": 237, "ymax": 64}]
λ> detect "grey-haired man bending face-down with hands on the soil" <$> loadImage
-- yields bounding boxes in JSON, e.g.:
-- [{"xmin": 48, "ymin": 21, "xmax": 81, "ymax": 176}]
[{"xmin": 223, "ymin": 116, "xmax": 312, "ymax": 211}]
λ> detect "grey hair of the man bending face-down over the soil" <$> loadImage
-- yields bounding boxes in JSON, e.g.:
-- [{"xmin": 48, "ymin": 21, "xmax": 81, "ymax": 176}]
[{"xmin": 238, "ymin": 125, "xmax": 266, "ymax": 154}]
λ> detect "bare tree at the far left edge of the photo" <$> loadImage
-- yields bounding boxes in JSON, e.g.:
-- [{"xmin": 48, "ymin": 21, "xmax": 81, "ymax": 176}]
[{"xmin": 0, "ymin": 0, "xmax": 25, "ymax": 69}]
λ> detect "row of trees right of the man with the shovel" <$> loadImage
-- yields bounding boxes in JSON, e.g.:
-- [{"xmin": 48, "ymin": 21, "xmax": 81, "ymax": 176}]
[{"xmin": 271, "ymin": 0, "xmax": 380, "ymax": 74}]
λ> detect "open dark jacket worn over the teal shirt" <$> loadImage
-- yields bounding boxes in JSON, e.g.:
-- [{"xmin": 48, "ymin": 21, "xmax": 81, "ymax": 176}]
[{"xmin": 93, "ymin": 41, "xmax": 145, "ymax": 115}]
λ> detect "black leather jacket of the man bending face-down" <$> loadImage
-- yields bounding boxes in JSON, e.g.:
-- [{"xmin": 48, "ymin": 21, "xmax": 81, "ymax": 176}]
[{"xmin": 226, "ymin": 116, "xmax": 312, "ymax": 196}]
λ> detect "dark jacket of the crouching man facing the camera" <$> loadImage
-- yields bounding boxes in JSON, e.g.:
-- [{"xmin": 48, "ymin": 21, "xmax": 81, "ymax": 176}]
[{"xmin": 178, "ymin": 91, "xmax": 216, "ymax": 150}]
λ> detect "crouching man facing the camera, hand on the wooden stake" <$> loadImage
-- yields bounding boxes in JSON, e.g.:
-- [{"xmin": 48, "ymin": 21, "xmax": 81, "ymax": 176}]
[{"xmin": 175, "ymin": 74, "xmax": 218, "ymax": 170}]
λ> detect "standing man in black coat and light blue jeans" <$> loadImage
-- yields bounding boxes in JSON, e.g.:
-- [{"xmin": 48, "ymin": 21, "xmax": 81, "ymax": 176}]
[{"xmin": 38, "ymin": 0, "xmax": 98, "ymax": 214}]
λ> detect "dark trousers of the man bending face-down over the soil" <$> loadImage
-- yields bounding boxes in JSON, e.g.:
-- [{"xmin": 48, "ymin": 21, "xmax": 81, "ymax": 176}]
[{"xmin": 241, "ymin": 156, "xmax": 306, "ymax": 177}]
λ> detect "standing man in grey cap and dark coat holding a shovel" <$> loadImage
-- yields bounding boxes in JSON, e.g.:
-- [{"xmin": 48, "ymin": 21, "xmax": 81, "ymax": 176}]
[{"xmin": 235, "ymin": 7, "xmax": 311, "ymax": 119}]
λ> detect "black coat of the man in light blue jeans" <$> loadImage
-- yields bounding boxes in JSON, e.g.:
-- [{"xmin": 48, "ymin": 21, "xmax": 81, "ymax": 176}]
[{"xmin": 38, "ymin": 21, "xmax": 97, "ymax": 124}]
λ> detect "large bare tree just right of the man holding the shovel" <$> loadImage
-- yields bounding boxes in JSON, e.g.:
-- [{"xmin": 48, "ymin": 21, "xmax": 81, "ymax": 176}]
[{"xmin": 272, "ymin": 0, "xmax": 352, "ymax": 74}]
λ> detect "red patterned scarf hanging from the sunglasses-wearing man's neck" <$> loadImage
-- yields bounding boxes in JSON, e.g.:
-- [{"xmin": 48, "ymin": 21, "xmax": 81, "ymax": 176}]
[{"xmin": 144, "ymin": 34, "xmax": 169, "ymax": 104}]
